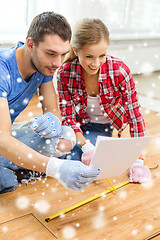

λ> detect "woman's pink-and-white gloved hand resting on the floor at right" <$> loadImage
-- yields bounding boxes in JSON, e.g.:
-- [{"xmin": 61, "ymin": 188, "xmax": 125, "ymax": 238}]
[{"xmin": 129, "ymin": 158, "xmax": 151, "ymax": 183}]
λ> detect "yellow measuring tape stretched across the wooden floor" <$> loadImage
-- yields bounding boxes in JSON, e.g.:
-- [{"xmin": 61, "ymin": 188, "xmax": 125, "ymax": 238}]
[{"xmin": 45, "ymin": 178, "xmax": 130, "ymax": 222}]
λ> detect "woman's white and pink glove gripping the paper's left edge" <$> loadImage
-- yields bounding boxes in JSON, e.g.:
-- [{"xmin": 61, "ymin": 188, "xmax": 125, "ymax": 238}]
[{"xmin": 81, "ymin": 141, "xmax": 95, "ymax": 166}]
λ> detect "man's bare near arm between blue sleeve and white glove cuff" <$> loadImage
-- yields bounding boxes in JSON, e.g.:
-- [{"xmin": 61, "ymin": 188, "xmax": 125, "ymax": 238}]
[{"xmin": 0, "ymin": 97, "xmax": 49, "ymax": 173}]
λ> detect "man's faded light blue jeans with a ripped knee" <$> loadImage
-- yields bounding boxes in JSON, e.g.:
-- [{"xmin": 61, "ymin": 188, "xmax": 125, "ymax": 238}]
[{"xmin": 0, "ymin": 122, "xmax": 76, "ymax": 193}]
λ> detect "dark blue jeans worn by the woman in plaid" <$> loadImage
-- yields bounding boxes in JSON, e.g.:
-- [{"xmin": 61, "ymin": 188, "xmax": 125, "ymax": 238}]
[{"xmin": 63, "ymin": 122, "xmax": 113, "ymax": 161}]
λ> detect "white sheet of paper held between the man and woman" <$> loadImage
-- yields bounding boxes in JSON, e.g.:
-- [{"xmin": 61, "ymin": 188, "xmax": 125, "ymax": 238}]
[{"xmin": 91, "ymin": 136, "xmax": 152, "ymax": 179}]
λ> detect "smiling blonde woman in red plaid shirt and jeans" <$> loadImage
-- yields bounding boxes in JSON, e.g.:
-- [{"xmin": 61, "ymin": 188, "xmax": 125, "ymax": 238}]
[{"xmin": 57, "ymin": 19, "xmax": 151, "ymax": 181}]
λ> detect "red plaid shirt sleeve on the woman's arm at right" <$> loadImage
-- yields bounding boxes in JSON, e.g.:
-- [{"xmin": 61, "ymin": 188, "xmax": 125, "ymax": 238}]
[{"xmin": 119, "ymin": 63, "xmax": 145, "ymax": 137}]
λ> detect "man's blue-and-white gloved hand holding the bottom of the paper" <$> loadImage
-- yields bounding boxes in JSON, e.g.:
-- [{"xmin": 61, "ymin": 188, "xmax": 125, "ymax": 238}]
[{"xmin": 46, "ymin": 157, "xmax": 100, "ymax": 191}]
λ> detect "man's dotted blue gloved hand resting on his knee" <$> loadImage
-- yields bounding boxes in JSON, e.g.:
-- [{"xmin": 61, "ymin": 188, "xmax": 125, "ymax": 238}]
[{"xmin": 30, "ymin": 112, "xmax": 61, "ymax": 138}]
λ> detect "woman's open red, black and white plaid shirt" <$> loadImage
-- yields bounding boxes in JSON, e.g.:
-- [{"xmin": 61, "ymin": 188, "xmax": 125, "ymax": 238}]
[{"xmin": 57, "ymin": 56, "xmax": 145, "ymax": 137}]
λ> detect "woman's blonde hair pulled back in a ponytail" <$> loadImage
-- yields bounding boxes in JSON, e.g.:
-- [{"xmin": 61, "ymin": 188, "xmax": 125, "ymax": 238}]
[{"xmin": 65, "ymin": 18, "xmax": 109, "ymax": 62}]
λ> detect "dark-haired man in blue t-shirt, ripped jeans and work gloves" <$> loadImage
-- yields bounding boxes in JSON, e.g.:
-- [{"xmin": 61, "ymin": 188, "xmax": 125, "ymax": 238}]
[{"xmin": 0, "ymin": 12, "xmax": 99, "ymax": 193}]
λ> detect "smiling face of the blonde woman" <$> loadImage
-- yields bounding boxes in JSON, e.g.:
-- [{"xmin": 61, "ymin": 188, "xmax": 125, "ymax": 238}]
[{"xmin": 75, "ymin": 40, "xmax": 108, "ymax": 75}]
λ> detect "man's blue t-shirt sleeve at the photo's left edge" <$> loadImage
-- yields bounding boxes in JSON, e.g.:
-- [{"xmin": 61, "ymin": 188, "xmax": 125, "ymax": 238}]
[{"xmin": 0, "ymin": 61, "xmax": 10, "ymax": 98}]
